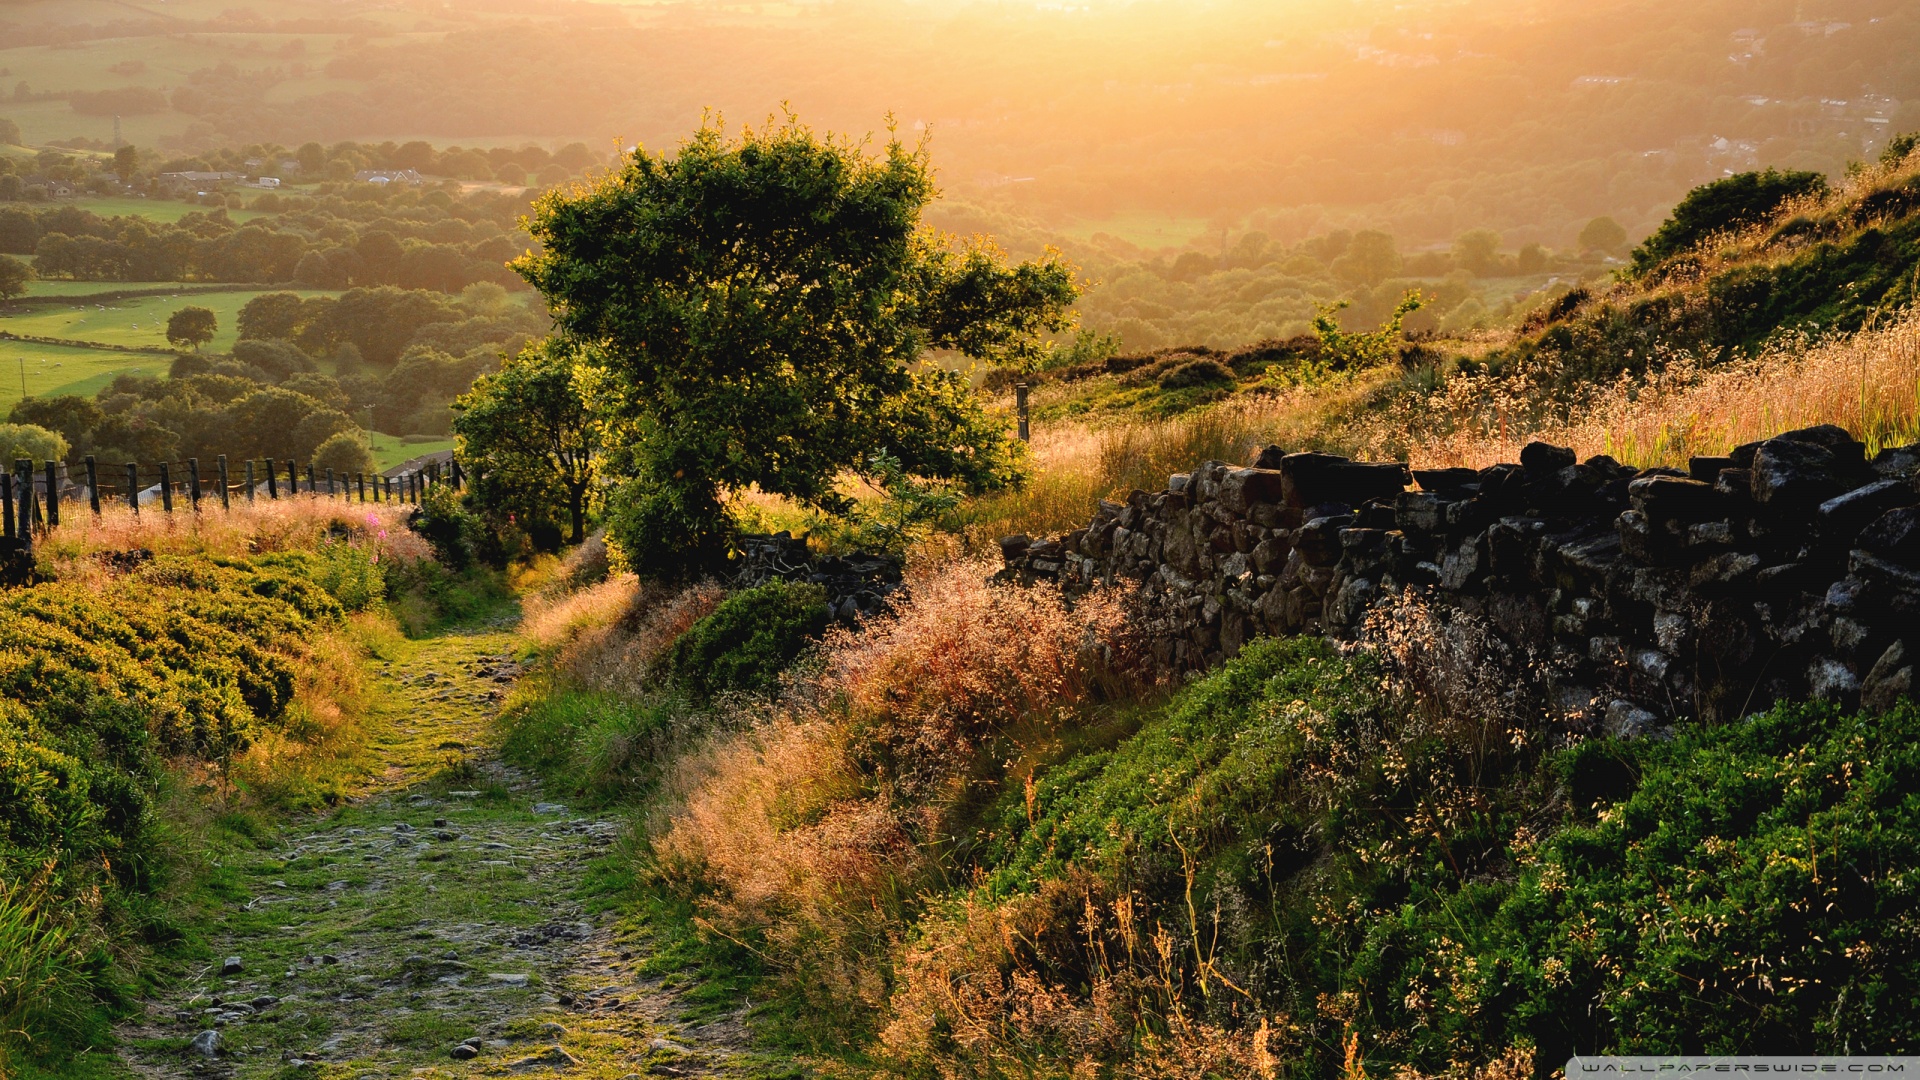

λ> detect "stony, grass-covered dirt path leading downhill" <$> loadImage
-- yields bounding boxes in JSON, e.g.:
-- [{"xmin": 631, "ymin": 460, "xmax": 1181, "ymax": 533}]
[{"xmin": 123, "ymin": 632, "xmax": 766, "ymax": 1080}]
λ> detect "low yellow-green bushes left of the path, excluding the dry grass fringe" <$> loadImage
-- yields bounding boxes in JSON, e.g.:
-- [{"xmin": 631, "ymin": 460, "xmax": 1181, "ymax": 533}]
[{"xmin": 0, "ymin": 553, "xmax": 353, "ymax": 1072}]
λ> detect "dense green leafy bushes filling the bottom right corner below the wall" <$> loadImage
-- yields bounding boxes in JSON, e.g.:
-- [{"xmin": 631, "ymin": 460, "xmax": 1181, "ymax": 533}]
[{"xmin": 1436, "ymin": 701, "xmax": 1920, "ymax": 1061}]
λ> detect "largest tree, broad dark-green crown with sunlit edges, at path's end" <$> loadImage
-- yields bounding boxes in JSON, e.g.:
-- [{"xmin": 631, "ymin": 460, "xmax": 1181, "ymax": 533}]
[{"xmin": 513, "ymin": 117, "xmax": 1079, "ymax": 577}]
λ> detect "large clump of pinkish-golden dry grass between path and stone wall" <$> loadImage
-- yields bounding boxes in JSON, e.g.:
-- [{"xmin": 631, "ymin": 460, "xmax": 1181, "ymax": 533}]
[{"xmin": 653, "ymin": 561, "xmax": 1125, "ymax": 1009}]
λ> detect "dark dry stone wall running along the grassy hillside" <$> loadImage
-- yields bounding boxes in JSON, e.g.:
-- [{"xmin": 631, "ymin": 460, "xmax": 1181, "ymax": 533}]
[{"xmin": 1000, "ymin": 425, "xmax": 1920, "ymax": 734}]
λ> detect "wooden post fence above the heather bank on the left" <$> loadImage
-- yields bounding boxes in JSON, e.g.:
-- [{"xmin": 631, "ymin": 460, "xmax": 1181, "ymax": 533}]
[{"xmin": 0, "ymin": 454, "xmax": 467, "ymax": 552}]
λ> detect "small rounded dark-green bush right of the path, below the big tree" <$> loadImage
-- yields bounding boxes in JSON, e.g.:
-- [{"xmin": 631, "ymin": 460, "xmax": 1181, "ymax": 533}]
[{"xmin": 660, "ymin": 580, "xmax": 831, "ymax": 701}]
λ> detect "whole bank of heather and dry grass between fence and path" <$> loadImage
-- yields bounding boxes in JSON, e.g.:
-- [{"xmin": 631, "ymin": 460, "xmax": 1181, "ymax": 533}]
[{"xmin": 0, "ymin": 500, "xmax": 449, "ymax": 1074}]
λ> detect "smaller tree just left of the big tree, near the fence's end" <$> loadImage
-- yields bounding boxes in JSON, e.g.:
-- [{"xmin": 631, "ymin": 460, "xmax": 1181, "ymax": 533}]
[{"xmin": 453, "ymin": 340, "xmax": 599, "ymax": 544}]
